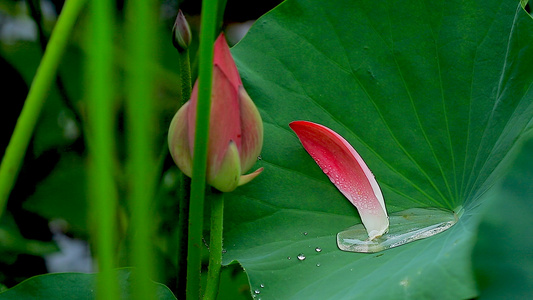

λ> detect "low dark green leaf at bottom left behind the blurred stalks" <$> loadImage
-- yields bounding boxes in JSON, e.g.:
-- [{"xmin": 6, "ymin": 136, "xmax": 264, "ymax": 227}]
[{"xmin": 0, "ymin": 269, "xmax": 176, "ymax": 300}]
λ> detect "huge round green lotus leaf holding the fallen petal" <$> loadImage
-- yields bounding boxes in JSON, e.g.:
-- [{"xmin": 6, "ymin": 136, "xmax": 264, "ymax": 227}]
[{"xmin": 224, "ymin": 0, "xmax": 533, "ymax": 299}]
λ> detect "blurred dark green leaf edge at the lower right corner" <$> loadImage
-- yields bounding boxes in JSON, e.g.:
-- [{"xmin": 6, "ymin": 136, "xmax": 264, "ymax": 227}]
[{"xmin": 472, "ymin": 135, "xmax": 533, "ymax": 299}]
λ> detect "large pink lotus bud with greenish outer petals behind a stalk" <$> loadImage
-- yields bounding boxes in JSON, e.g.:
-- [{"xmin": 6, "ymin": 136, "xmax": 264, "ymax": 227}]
[{"xmin": 168, "ymin": 34, "xmax": 263, "ymax": 192}]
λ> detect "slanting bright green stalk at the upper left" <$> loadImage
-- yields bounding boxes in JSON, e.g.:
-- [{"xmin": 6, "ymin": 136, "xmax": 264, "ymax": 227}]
[{"xmin": 0, "ymin": 0, "xmax": 85, "ymax": 217}]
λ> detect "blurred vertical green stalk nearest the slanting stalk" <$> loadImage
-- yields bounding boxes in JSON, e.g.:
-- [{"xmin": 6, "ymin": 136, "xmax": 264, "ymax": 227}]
[{"xmin": 88, "ymin": 0, "xmax": 119, "ymax": 299}]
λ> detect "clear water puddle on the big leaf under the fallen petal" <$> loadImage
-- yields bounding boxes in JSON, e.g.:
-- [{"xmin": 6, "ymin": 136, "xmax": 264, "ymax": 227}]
[{"xmin": 337, "ymin": 207, "xmax": 462, "ymax": 253}]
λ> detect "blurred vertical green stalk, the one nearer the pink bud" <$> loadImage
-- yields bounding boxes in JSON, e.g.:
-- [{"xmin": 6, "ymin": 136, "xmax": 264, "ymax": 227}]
[{"xmin": 126, "ymin": 0, "xmax": 156, "ymax": 300}]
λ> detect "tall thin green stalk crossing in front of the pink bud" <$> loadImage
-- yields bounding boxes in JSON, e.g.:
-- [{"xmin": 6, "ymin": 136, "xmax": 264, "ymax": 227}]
[{"xmin": 186, "ymin": 0, "xmax": 217, "ymax": 300}]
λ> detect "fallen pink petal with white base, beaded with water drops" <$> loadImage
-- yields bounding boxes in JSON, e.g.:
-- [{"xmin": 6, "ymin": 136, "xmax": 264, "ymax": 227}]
[{"xmin": 289, "ymin": 121, "xmax": 389, "ymax": 240}]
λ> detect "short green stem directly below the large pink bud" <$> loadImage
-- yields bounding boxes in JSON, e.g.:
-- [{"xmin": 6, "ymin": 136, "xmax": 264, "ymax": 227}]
[{"xmin": 204, "ymin": 191, "xmax": 224, "ymax": 300}]
